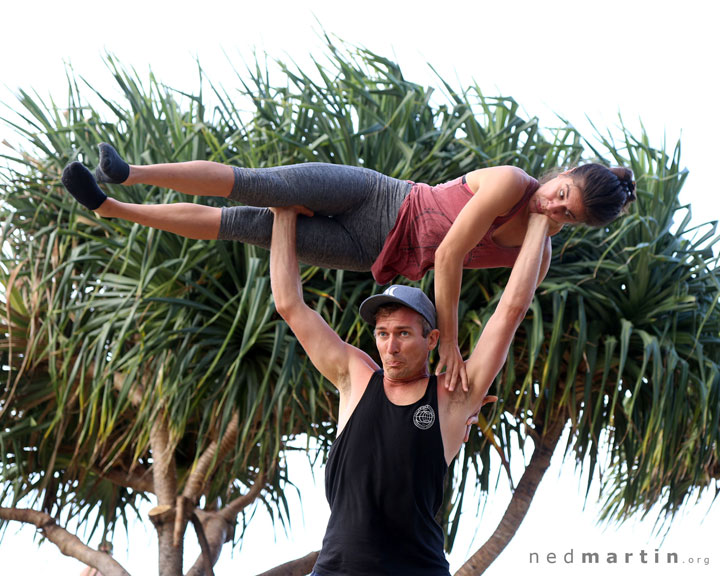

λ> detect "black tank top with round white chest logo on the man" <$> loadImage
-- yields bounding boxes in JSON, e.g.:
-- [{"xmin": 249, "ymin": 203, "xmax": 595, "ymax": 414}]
[{"xmin": 315, "ymin": 371, "xmax": 450, "ymax": 576}]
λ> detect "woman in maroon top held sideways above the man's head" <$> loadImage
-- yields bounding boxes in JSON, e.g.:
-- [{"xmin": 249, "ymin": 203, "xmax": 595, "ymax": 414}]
[{"xmin": 62, "ymin": 143, "xmax": 635, "ymax": 389}]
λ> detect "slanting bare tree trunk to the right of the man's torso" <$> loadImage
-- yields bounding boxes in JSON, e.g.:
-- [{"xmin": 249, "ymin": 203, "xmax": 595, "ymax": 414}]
[{"xmin": 455, "ymin": 415, "xmax": 565, "ymax": 576}]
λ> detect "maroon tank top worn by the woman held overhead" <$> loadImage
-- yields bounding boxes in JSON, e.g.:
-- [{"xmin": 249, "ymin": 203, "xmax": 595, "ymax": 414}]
[{"xmin": 372, "ymin": 177, "xmax": 539, "ymax": 284}]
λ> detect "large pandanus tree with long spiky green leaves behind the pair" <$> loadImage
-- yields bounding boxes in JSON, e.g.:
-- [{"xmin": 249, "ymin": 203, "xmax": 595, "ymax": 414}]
[{"xmin": 0, "ymin": 42, "xmax": 720, "ymax": 576}]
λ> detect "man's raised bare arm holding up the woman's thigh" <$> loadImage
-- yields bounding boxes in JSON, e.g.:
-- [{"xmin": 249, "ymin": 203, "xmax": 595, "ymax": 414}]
[{"xmin": 270, "ymin": 208, "xmax": 377, "ymax": 392}]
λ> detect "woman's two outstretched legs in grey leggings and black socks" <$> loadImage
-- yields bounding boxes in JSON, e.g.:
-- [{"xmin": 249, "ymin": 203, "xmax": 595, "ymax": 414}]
[{"xmin": 69, "ymin": 144, "xmax": 411, "ymax": 260}]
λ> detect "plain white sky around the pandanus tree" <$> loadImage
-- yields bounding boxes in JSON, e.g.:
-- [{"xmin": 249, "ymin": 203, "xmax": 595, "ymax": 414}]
[{"xmin": 0, "ymin": 0, "xmax": 720, "ymax": 576}]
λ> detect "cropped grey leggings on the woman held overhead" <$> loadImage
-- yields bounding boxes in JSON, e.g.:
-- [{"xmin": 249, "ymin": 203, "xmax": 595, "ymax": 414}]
[{"xmin": 218, "ymin": 163, "xmax": 412, "ymax": 271}]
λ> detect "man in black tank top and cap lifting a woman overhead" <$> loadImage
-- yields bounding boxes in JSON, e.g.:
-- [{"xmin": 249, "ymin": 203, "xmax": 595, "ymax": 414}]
[{"xmin": 270, "ymin": 209, "xmax": 549, "ymax": 576}]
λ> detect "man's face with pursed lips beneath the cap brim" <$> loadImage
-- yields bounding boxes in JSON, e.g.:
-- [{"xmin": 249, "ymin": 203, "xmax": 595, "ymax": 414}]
[{"xmin": 375, "ymin": 308, "xmax": 438, "ymax": 380}]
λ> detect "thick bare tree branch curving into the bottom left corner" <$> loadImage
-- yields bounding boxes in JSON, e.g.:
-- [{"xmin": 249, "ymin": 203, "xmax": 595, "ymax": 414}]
[{"xmin": 0, "ymin": 508, "xmax": 130, "ymax": 576}]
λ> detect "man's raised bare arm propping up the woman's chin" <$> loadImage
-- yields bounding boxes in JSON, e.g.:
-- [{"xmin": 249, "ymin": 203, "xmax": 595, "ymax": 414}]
[{"xmin": 466, "ymin": 214, "xmax": 550, "ymax": 411}]
